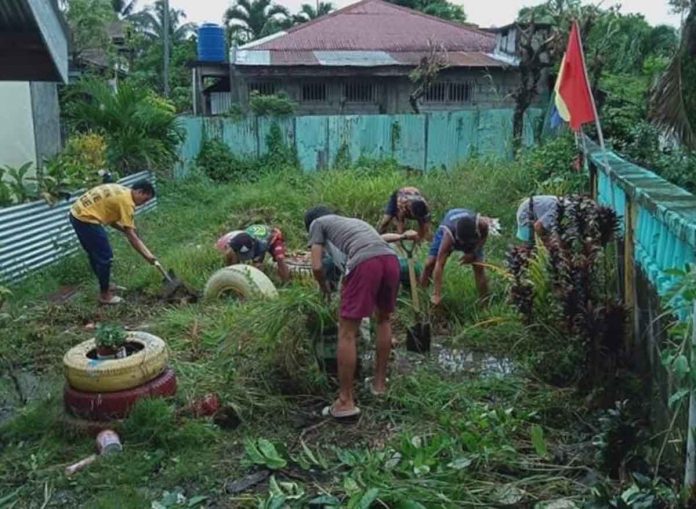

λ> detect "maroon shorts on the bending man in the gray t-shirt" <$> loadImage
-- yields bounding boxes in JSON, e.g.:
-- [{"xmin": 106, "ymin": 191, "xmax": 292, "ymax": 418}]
[{"xmin": 341, "ymin": 255, "xmax": 401, "ymax": 320}]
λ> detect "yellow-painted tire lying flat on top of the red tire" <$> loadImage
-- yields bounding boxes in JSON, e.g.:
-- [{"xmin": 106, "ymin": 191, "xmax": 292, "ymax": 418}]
[{"xmin": 63, "ymin": 332, "xmax": 169, "ymax": 392}]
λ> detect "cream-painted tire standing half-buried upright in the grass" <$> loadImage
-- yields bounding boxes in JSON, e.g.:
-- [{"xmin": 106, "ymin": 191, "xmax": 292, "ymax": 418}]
[{"xmin": 203, "ymin": 264, "xmax": 278, "ymax": 299}]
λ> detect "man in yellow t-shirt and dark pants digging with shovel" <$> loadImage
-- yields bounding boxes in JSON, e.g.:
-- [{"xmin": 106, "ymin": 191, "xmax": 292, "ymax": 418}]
[{"xmin": 70, "ymin": 181, "xmax": 157, "ymax": 304}]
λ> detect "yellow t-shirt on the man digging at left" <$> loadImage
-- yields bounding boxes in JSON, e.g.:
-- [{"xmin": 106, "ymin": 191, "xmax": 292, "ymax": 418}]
[{"xmin": 70, "ymin": 184, "xmax": 135, "ymax": 228}]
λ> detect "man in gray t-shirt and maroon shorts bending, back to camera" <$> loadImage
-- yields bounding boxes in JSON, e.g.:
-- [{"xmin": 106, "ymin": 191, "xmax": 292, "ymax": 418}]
[{"xmin": 305, "ymin": 206, "xmax": 418, "ymax": 419}]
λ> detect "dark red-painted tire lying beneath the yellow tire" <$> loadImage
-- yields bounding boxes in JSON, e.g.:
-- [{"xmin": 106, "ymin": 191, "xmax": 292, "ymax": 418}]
[{"xmin": 63, "ymin": 368, "xmax": 176, "ymax": 421}]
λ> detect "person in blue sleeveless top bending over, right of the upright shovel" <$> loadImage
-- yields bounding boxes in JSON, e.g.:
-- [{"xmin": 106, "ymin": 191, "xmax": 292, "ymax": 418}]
[{"xmin": 421, "ymin": 209, "xmax": 500, "ymax": 306}]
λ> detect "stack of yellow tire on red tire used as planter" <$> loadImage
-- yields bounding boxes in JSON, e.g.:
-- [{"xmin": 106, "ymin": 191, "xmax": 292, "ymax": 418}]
[{"xmin": 63, "ymin": 332, "xmax": 176, "ymax": 422}]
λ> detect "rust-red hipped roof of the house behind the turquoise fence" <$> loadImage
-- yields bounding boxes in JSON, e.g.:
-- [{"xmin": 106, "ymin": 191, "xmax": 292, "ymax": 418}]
[{"xmin": 242, "ymin": 0, "xmax": 495, "ymax": 53}]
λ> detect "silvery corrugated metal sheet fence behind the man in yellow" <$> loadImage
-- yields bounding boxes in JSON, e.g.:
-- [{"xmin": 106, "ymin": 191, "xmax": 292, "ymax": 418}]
[{"xmin": 0, "ymin": 172, "xmax": 157, "ymax": 283}]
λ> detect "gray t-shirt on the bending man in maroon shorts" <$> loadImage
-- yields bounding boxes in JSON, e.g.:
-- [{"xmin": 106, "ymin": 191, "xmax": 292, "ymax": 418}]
[{"xmin": 309, "ymin": 215, "xmax": 396, "ymax": 274}]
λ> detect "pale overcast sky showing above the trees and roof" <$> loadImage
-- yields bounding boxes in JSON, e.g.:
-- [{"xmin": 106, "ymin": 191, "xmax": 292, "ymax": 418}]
[{"xmin": 137, "ymin": 0, "xmax": 679, "ymax": 27}]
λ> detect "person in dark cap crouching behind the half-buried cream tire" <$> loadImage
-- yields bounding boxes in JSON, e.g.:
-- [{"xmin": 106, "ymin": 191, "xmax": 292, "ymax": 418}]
[{"xmin": 215, "ymin": 224, "xmax": 290, "ymax": 282}]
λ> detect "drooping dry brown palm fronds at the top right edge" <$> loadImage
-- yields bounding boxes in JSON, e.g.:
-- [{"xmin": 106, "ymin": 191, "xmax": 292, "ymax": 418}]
[{"xmin": 650, "ymin": 0, "xmax": 696, "ymax": 150}]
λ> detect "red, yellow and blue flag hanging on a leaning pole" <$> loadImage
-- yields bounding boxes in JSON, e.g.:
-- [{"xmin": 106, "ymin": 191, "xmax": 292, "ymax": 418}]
[{"xmin": 555, "ymin": 21, "xmax": 596, "ymax": 131}]
